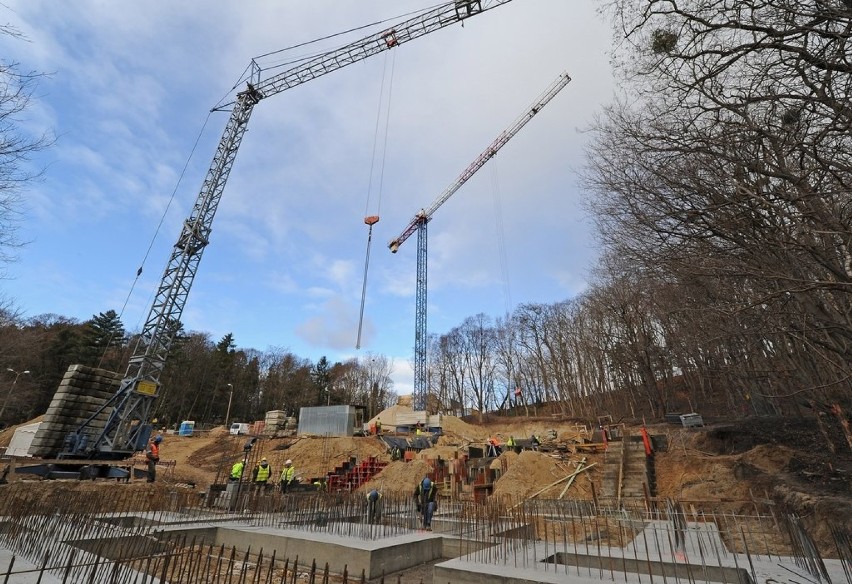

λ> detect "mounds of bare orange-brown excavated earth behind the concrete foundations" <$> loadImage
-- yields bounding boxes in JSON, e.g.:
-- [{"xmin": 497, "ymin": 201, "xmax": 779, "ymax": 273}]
[{"xmin": 0, "ymin": 416, "xmax": 852, "ymax": 560}]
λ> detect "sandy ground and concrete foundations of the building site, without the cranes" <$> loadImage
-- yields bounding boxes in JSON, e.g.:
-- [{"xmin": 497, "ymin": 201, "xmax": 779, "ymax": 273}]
[{"xmin": 0, "ymin": 384, "xmax": 852, "ymax": 584}]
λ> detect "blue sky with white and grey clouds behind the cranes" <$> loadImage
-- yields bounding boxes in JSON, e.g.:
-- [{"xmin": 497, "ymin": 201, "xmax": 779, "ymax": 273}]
[{"xmin": 0, "ymin": 0, "xmax": 613, "ymax": 394}]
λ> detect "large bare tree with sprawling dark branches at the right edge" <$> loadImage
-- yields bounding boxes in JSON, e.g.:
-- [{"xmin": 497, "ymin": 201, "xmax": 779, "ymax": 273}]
[{"xmin": 585, "ymin": 0, "xmax": 852, "ymax": 404}]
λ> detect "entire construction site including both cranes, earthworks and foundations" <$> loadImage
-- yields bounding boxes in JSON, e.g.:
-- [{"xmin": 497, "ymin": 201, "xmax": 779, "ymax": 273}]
[{"xmin": 0, "ymin": 0, "xmax": 852, "ymax": 584}]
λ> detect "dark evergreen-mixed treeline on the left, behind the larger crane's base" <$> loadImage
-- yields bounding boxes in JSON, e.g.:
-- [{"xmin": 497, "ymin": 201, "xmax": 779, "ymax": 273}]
[{"xmin": 0, "ymin": 310, "xmax": 396, "ymax": 426}]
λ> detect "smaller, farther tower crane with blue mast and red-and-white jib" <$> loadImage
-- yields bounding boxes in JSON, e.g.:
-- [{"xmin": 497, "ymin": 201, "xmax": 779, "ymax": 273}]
[{"xmin": 388, "ymin": 73, "xmax": 571, "ymax": 409}]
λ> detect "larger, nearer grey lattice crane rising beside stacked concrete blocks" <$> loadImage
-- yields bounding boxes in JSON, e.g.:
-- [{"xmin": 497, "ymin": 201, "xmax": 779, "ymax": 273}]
[{"xmin": 59, "ymin": 0, "xmax": 511, "ymax": 460}]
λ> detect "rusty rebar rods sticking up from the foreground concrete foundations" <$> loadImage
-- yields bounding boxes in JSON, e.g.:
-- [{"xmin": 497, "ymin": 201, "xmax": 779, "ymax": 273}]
[{"xmin": 0, "ymin": 483, "xmax": 852, "ymax": 584}]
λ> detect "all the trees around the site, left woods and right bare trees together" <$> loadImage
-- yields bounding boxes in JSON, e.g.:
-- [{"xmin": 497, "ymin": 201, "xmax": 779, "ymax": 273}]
[{"xmin": 0, "ymin": 0, "xmax": 852, "ymax": 422}]
